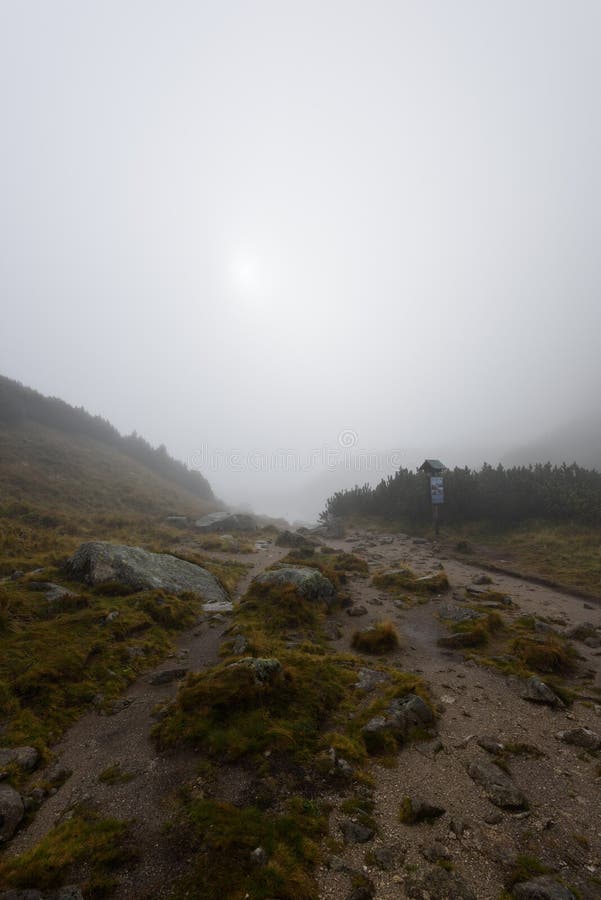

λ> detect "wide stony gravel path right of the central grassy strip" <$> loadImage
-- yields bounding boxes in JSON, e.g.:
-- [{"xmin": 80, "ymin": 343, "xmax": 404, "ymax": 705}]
[{"xmin": 319, "ymin": 534, "xmax": 601, "ymax": 900}]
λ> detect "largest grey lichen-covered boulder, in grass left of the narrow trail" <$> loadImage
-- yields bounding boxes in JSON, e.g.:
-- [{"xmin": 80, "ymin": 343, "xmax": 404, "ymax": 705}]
[{"xmin": 65, "ymin": 541, "xmax": 232, "ymax": 612}]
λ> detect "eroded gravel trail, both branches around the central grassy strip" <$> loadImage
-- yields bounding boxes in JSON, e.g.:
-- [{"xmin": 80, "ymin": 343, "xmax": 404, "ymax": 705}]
[{"xmin": 9, "ymin": 531, "xmax": 601, "ymax": 900}]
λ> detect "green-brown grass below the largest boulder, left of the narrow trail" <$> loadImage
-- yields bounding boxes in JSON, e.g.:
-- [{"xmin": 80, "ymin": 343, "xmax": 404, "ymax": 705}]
[{"xmin": 0, "ymin": 572, "xmax": 202, "ymax": 756}]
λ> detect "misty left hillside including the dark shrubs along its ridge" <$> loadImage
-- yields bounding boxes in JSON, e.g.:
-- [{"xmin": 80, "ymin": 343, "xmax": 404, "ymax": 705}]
[{"xmin": 0, "ymin": 377, "xmax": 219, "ymax": 575}]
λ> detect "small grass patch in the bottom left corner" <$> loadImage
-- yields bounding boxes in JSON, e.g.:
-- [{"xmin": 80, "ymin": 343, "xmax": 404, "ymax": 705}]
[{"xmin": 0, "ymin": 807, "xmax": 135, "ymax": 900}]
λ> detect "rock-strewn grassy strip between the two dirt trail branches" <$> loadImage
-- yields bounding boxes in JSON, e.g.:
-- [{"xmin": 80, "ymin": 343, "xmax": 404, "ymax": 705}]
[{"xmin": 155, "ymin": 561, "xmax": 424, "ymax": 900}]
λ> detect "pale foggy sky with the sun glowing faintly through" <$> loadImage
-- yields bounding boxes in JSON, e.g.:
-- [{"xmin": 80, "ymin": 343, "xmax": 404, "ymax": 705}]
[{"xmin": 0, "ymin": 0, "xmax": 601, "ymax": 514}]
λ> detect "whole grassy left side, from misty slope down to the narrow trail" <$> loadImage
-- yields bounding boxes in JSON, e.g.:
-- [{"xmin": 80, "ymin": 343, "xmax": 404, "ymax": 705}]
[{"xmin": 0, "ymin": 398, "xmax": 239, "ymax": 756}]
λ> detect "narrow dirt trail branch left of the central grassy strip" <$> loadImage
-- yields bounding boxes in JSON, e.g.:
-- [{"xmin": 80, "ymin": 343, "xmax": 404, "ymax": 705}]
[{"xmin": 6, "ymin": 546, "xmax": 287, "ymax": 900}]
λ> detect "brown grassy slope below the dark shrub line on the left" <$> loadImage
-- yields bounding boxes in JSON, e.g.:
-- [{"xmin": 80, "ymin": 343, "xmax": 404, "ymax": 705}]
[{"xmin": 0, "ymin": 422, "xmax": 217, "ymax": 575}]
